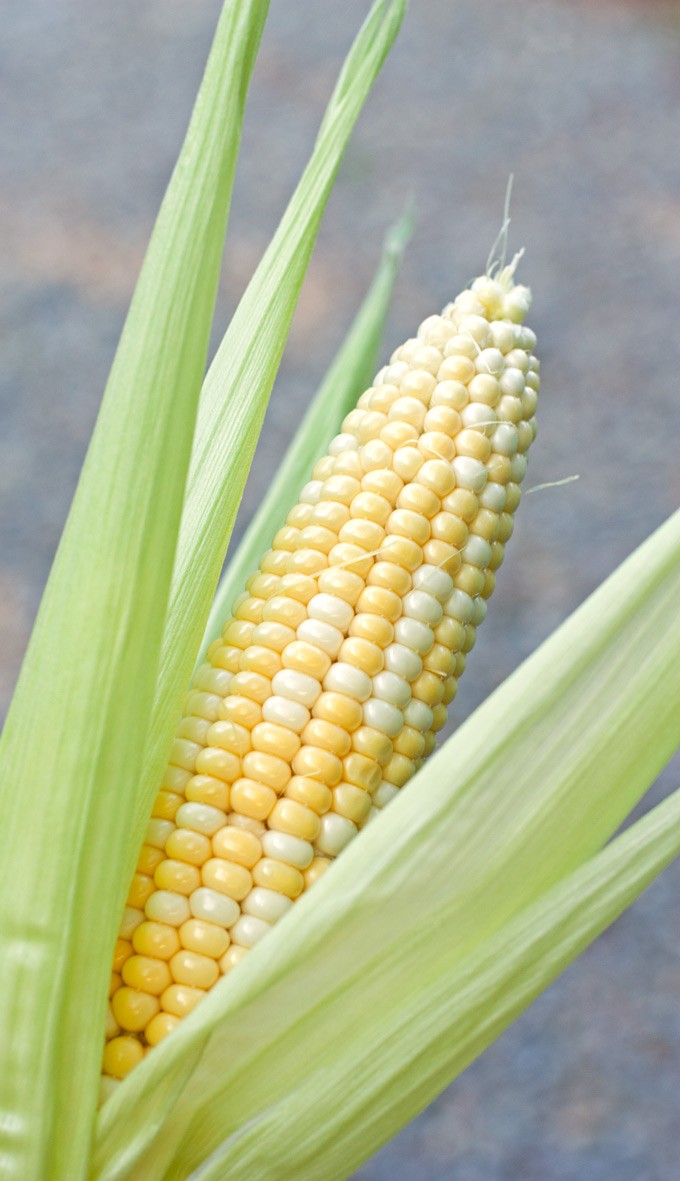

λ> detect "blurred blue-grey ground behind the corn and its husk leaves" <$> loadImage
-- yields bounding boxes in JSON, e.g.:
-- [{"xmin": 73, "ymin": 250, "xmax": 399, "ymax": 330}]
[{"xmin": 0, "ymin": 0, "xmax": 680, "ymax": 1181}]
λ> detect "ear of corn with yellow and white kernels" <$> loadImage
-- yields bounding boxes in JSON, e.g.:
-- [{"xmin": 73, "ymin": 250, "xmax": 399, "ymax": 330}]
[{"xmin": 104, "ymin": 267, "xmax": 538, "ymax": 1094}]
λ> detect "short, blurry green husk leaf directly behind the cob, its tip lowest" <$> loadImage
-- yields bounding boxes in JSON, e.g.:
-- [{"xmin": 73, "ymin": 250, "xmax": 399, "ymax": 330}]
[{"xmin": 202, "ymin": 214, "xmax": 413, "ymax": 650}]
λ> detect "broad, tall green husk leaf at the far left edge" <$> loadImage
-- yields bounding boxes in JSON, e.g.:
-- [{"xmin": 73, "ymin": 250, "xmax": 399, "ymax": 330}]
[{"xmin": 0, "ymin": 0, "xmax": 267, "ymax": 1181}]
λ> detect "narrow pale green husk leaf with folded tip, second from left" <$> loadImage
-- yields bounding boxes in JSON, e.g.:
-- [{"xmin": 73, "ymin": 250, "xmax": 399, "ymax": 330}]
[{"xmin": 131, "ymin": 0, "xmax": 405, "ymax": 843}]
